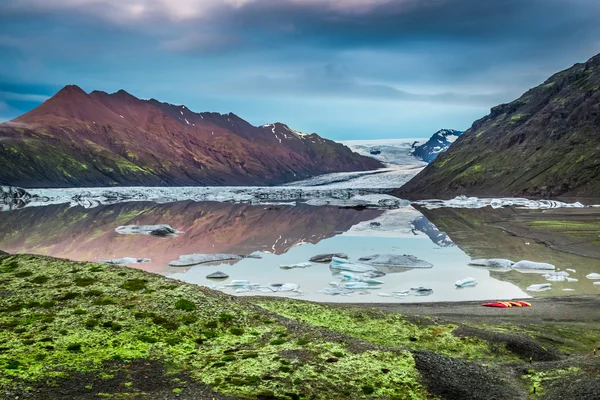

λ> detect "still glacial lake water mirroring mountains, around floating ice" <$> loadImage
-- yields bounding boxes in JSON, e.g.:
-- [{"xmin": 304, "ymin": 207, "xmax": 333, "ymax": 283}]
[{"xmin": 0, "ymin": 194, "xmax": 600, "ymax": 302}]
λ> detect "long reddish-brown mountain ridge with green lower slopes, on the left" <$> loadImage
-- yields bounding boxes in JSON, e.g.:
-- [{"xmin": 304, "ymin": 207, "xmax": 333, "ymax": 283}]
[{"xmin": 0, "ymin": 85, "xmax": 382, "ymax": 187}]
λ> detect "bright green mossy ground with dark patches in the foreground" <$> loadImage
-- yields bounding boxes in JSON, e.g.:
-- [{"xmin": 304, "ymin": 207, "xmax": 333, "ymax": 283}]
[{"xmin": 0, "ymin": 253, "xmax": 600, "ymax": 400}]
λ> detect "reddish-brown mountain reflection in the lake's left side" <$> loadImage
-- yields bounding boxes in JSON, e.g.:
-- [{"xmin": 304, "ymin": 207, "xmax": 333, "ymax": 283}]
[{"xmin": 0, "ymin": 201, "xmax": 383, "ymax": 272}]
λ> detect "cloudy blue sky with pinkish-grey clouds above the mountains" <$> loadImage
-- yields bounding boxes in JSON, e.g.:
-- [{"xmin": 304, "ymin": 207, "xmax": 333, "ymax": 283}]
[{"xmin": 0, "ymin": 0, "xmax": 600, "ymax": 140}]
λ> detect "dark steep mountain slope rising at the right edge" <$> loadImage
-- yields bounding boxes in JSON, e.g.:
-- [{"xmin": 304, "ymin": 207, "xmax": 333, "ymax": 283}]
[{"xmin": 395, "ymin": 54, "xmax": 600, "ymax": 199}]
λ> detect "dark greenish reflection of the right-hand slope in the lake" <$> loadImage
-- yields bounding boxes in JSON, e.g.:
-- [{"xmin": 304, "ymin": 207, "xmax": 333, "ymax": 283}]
[{"xmin": 420, "ymin": 207, "xmax": 600, "ymax": 297}]
